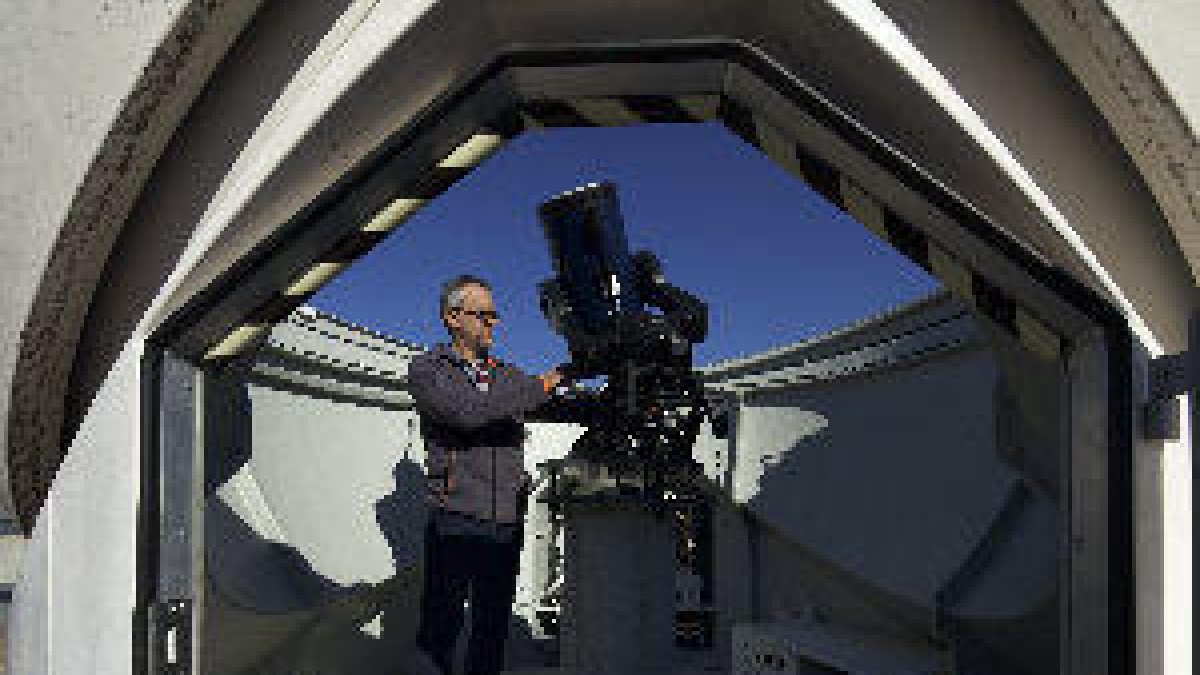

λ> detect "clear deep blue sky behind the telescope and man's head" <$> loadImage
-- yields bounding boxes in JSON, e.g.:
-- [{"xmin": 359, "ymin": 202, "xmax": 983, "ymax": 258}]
[{"xmin": 308, "ymin": 123, "xmax": 940, "ymax": 372}]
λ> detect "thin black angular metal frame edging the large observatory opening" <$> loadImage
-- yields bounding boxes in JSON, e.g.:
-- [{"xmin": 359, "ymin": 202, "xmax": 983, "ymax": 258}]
[{"xmin": 133, "ymin": 40, "xmax": 1135, "ymax": 675}]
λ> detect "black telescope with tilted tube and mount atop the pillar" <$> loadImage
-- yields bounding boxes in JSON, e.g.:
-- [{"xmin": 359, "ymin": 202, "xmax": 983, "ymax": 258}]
[{"xmin": 539, "ymin": 183, "xmax": 716, "ymax": 498}]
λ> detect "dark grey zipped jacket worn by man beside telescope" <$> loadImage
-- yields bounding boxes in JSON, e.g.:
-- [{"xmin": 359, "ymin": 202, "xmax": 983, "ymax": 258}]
[{"xmin": 408, "ymin": 344, "xmax": 597, "ymax": 524}]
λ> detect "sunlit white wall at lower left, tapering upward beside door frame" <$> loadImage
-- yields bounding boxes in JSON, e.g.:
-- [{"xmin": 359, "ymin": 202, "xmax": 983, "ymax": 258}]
[{"xmin": 12, "ymin": 346, "xmax": 140, "ymax": 675}]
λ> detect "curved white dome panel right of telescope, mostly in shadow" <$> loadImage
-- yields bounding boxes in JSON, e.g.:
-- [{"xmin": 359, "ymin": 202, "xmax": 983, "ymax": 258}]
[{"xmin": 736, "ymin": 343, "xmax": 1012, "ymax": 603}]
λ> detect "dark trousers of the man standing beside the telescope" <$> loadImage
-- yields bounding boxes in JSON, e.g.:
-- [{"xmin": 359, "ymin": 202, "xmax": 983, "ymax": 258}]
[{"xmin": 416, "ymin": 516, "xmax": 522, "ymax": 675}]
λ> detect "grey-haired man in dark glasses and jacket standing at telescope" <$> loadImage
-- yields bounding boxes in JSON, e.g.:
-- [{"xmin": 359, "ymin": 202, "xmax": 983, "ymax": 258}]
[{"xmin": 408, "ymin": 275, "xmax": 585, "ymax": 675}]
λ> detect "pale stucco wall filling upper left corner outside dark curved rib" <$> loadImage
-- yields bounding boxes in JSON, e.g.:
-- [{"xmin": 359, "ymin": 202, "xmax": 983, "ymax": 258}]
[{"xmin": 0, "ymin": 0, "xmax": 180, "ymax": 510}]
